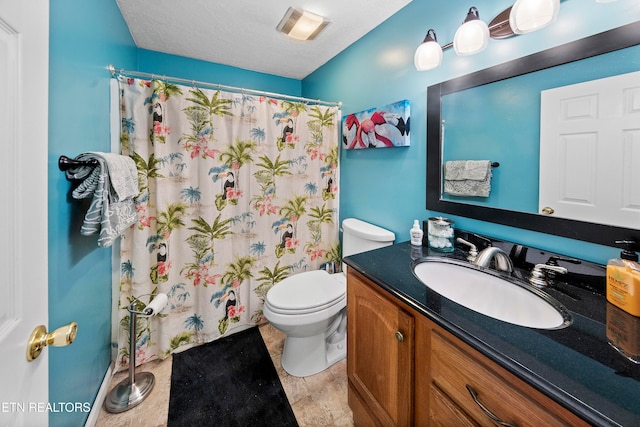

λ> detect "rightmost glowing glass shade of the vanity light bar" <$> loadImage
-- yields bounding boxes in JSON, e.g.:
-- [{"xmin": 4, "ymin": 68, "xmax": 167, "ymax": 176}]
[{"xmin": 509, "ymin": 0, "xmax": 560, "ymax": 34}]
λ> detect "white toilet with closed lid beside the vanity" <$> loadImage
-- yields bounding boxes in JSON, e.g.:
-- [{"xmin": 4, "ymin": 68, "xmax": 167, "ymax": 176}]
[{"xmin": 263, "ymin": 218, "xmax": 395, "ymax": 377}]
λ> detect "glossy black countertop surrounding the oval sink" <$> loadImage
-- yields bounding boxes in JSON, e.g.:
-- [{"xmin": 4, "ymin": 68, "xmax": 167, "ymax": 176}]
[{"xmin": 344, "ymin": 237, "xmax": 640, "ymax": 426}]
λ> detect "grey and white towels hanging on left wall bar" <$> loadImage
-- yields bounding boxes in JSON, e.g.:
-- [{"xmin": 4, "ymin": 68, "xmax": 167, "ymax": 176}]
[{"xmin": 67, "ymin": 152, "xmax": 138, "ymax": 248}]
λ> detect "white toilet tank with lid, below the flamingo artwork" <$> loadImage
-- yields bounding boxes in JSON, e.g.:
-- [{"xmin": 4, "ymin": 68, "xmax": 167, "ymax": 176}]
[{"xmin": 342, "ymin": 218, "xmax": 396, "ymax": 258}]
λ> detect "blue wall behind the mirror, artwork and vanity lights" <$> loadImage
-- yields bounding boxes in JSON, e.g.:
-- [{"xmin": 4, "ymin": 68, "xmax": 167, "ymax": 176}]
[{"xmin": 302, "ymin": 0, "xmax": 640, "ymax": 263}]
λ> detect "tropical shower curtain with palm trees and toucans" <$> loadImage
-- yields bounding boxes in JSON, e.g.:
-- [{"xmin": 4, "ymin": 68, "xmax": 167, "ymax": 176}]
[{"xmin": 116, "ymin": 76, "xmax": 340, "ymax": 369}]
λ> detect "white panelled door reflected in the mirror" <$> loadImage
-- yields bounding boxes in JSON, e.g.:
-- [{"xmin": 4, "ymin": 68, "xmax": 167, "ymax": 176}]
[{"xmin": 539, "ymin": 72, "xmax": 640, "ymax": 228}]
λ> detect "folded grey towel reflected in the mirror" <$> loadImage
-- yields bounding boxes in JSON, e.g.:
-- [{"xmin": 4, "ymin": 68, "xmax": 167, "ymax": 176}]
[{"xmin": 444, "ymin": 160, "xmax": 491, "ymax": 197}]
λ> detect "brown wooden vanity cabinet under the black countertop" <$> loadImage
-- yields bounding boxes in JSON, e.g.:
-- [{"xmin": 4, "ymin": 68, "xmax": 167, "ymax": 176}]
[{"xmin": 347, "ymin": 269, "xmax": 589, "ymax": 427}]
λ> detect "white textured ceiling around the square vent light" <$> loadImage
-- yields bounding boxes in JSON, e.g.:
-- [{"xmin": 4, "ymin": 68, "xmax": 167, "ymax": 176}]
[{"xmin": 116, "ymin": 0, "xmax": 411, "ymax": 79}]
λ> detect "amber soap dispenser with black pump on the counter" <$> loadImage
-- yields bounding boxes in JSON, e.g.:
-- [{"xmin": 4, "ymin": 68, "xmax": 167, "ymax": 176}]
[{"xmin": 607, "ymin": 240, "xmax": 640, "ymax": 317}]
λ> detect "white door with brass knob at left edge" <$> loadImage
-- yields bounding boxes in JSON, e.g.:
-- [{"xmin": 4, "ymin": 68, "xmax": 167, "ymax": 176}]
[{"xmin": 0, "ymin": 0, "xmax": 49, "ymax": 427}]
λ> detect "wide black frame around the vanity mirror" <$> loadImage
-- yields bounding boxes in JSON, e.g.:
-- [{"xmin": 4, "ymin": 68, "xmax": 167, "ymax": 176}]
[{"xmin": 426, "ymin": 22, "xmax": 640, "ymax": 246}]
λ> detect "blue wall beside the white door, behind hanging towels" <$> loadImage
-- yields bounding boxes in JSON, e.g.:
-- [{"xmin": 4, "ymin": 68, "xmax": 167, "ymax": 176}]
[{"xmin": 48, "ymin": 0, "xmax": 136, "ymax": 426}]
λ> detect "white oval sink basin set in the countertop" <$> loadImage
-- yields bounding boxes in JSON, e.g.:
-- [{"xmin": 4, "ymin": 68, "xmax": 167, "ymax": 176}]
[{"xmin": 413, "ymin": 258, "xmax": 571, "ymax": 329}]
